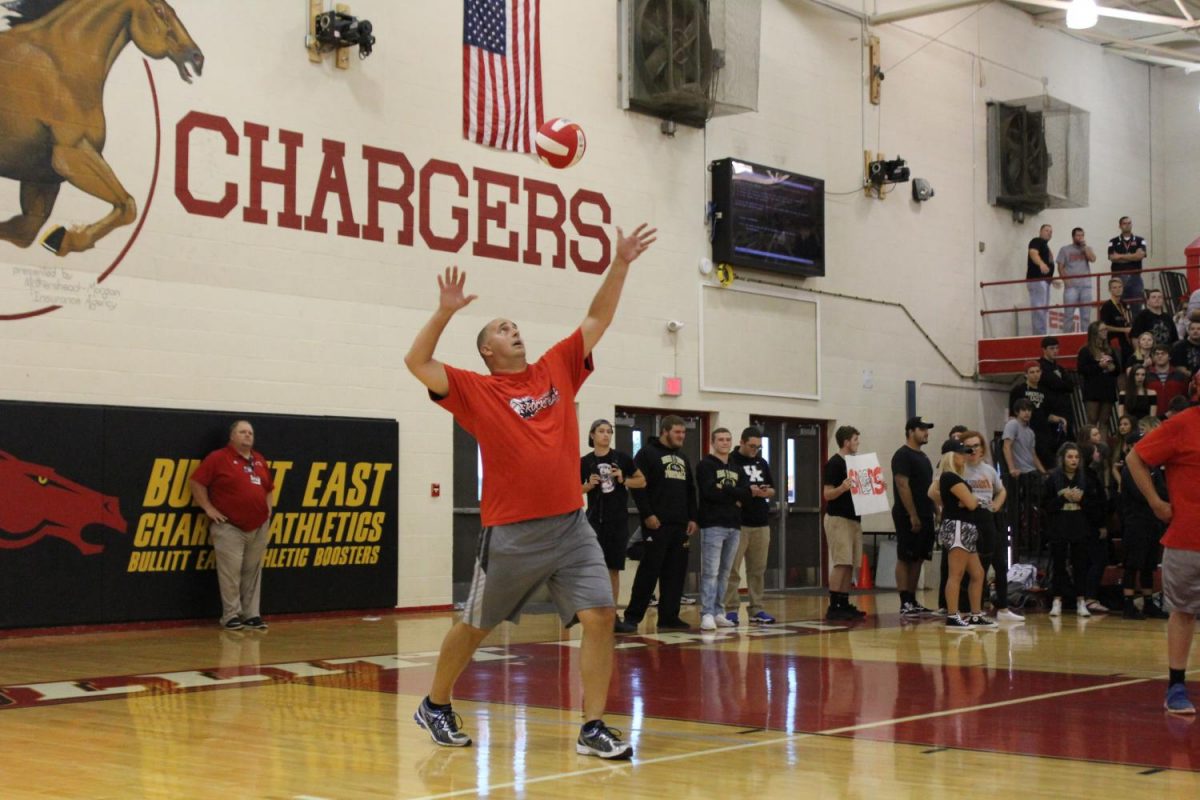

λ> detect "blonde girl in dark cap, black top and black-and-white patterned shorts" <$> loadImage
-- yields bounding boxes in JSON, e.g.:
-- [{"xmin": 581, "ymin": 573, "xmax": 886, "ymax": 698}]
[{"xmin": 938, "ymin": 440, "xmax": 996, "ymax": 630}]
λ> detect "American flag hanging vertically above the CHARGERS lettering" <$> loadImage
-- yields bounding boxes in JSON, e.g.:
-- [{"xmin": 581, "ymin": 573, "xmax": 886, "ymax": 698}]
[{"xmin": 462, "ymin": 0, "xmax": 542, "ymax": 152}]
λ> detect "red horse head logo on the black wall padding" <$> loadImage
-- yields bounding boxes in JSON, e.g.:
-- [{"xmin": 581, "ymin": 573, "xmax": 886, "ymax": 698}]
[{"xmin": 0, "ymin": 451, "xmax": 126, "ymax": 555}]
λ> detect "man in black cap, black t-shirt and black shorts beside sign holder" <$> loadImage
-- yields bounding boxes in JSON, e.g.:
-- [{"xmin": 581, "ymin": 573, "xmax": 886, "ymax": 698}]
[{"xmin": 892, "ymin": 416, "xmax": 934, "ymax": 616}]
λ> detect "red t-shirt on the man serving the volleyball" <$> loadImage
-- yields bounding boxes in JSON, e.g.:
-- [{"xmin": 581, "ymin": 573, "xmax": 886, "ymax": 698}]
[{"xmin": 430, "ymin": 329, "xmax": 593, "ymax": 527}]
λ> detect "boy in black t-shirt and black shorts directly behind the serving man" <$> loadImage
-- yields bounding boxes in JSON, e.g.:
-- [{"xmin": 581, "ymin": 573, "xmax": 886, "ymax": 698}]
[{"xmin": 580, "ymin": 420, "xmax": 646, "ymax": 633}]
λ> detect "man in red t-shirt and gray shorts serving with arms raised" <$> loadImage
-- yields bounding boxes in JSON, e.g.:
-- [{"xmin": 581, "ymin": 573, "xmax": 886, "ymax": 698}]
[{"xmin": 404, "ymin": 224, "xmax": 655, "ymax": 758}]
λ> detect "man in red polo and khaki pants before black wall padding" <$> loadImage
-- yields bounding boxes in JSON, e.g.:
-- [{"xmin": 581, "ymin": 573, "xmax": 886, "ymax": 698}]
[{"xmin": 191, "ymin": 420, "xmax": 275, "ymax": 631}]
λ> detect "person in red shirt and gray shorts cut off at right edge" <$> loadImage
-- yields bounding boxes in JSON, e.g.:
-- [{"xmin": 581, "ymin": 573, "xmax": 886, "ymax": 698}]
[{"xmin": 1126, "ymin": 407, "xmax": 1200, "ymax": 714}]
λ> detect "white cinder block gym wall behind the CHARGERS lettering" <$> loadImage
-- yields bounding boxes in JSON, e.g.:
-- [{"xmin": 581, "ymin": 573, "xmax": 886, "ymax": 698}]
[{"xmin": 0, "ymin": 0, "xmax": 1200, "ymax": 607}]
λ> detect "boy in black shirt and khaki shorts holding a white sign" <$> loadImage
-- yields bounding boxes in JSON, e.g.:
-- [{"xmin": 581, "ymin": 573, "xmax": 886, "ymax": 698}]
[{"xmin": 821, "ymin": 425, "xmax": 870, "ymax": 620}]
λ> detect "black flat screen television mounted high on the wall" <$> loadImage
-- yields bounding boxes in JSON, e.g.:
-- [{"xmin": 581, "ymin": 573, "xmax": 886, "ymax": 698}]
[{"xmin": 712, "ymin": 158, "xmax": 824, "ymax": 277}]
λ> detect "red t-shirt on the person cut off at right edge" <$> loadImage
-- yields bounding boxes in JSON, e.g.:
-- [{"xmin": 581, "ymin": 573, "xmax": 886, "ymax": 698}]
[{"xmin": 1134, "ymin": 408, "xmax": 1200, "ymax": 551}]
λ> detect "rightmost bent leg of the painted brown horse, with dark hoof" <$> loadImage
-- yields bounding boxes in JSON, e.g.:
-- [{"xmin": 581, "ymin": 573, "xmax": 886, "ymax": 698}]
[{"xmin": 42, "ymin": 139, "xmax": 138, "ymax": 255}]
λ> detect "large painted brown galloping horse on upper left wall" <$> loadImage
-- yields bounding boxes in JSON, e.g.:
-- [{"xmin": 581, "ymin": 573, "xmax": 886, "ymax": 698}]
[{"xmin": 0, "ymin": 0, "xmax": 204, "ymax": 255}]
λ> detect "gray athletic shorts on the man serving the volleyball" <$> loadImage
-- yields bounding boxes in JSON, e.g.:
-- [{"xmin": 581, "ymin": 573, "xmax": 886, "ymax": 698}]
[{"xmin": 462, "ymin": 509, "xmax": 614, "ymax": 630}]
